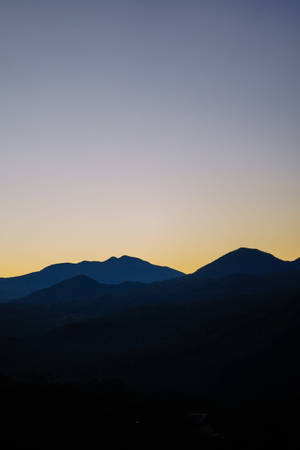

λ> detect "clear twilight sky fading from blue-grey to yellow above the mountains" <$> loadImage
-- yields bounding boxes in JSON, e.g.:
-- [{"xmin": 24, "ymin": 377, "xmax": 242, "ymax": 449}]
[{"xmin": 0, "ymin": 0, "xmax": 300, "ymax": 276}]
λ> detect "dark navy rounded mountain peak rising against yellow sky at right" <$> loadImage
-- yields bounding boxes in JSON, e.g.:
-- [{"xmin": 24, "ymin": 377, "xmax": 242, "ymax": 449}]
[{"xmin": 193, "ymin": 247, "xmax": 300, "ymax": 278}]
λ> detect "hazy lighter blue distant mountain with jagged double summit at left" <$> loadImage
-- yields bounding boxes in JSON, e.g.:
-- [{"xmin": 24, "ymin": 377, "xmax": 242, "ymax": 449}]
[{"xmin": 0, "ymin": 255, "xmax": 184, "ymax": 301}]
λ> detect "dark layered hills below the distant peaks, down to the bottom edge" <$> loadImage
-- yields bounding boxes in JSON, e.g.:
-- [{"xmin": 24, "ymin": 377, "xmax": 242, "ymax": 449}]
[{"xmin": 0, "ymin": 271, "xmax": 300, "ymax": 449}]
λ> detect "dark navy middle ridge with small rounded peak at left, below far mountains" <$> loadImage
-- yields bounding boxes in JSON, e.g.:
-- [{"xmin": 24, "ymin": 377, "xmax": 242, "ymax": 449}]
[{"xmin": 0, "ymin": 271, "xmax": 299, "ymax": 337}]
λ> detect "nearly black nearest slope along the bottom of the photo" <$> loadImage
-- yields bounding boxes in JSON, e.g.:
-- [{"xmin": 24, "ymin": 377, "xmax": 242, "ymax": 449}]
[{"xmin": 0, "ymin": 374, "xmax": 299, "ymax": 450}]
